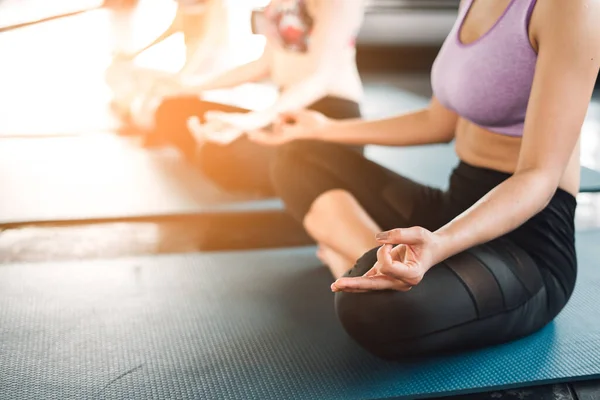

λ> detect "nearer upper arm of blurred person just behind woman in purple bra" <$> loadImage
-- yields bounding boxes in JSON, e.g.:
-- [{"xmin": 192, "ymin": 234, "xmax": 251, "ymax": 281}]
[{"xmin": 309, "ymin": 0, "xmax": 365, "ymax": 68}]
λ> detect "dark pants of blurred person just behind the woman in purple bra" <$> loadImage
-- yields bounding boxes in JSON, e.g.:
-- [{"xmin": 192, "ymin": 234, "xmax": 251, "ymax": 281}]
[{"xmin": 152, "ymin": 96, "xmax": 360, "ymax": 195}]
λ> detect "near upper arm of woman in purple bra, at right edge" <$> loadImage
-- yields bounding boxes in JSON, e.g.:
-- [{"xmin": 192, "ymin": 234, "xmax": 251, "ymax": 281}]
[{"xmin": 516, "ymin": 0, "xmax": 600, "ymax": 181}]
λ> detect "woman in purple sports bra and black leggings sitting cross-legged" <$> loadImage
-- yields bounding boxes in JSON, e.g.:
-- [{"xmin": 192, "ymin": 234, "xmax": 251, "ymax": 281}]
[{"xmin": 252, "ymin": 0, "xmax": 600, "ymax": 359}]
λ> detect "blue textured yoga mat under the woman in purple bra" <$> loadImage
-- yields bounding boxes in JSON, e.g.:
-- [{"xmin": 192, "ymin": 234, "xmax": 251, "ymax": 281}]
[{"xmin": 0, "ymin": 231, "xmax": 600, "ymax": 400}]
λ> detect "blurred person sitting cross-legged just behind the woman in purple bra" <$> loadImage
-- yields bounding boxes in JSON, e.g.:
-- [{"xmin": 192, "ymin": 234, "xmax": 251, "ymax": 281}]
[{"xmin": 145, "ymin": 0, "xmax": 365, "ymax": 195}]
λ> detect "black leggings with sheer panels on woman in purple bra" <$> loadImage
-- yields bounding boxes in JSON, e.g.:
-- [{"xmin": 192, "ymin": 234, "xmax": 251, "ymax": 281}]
[{"xmin": 273, "ymin": 141, "xmax": 576, "ymax": 360}]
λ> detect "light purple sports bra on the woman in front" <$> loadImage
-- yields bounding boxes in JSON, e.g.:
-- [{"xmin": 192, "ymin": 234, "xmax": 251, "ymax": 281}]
[{"xmin": 431, "ymin": 0, "xmax": 537, "ymax": 136}]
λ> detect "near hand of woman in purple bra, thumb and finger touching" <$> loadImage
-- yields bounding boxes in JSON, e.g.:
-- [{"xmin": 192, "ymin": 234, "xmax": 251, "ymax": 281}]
[{"xmin": 331, "ymin": 227, "xmax": 438, "ymax": 293}]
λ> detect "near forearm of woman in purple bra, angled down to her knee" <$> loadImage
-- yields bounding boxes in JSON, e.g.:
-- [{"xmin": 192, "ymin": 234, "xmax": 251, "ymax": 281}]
[{"xmin": 435, "ymin": 170, "xmax": 557, "ymax": 263}]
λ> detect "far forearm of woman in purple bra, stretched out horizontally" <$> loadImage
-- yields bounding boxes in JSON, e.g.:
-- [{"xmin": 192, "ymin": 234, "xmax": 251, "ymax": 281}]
[{"xmin": 316, "ymin": 108, "xmax": 454, "ymax": 146}]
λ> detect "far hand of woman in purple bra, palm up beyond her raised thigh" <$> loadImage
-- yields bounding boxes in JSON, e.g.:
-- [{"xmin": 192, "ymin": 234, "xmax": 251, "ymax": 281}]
[{"xmin": 249, "ymin": 110, "xmax": 332, "ymax": 146}]
